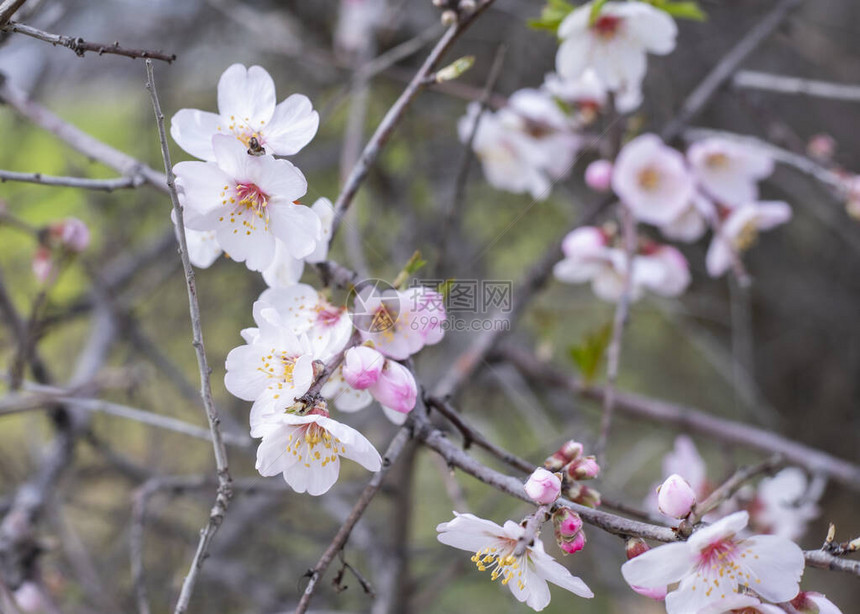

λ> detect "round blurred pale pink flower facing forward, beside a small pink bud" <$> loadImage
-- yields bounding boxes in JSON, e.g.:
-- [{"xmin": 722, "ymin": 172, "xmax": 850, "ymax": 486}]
[{"xmin": 612, "ymin": 134, "xmax": 693, "ymax": 226}]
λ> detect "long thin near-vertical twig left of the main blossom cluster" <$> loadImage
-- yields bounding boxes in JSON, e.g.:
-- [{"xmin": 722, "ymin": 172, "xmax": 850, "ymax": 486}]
[{"xmin": 146, "ymin": 60, "xmax": 233, "ymax": 614}]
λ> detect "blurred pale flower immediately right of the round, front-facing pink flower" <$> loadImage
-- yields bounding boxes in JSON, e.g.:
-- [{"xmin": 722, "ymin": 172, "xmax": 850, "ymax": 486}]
[{"xmin": 687, "ymin": 137, "xmax": 773, "ymax": 207}]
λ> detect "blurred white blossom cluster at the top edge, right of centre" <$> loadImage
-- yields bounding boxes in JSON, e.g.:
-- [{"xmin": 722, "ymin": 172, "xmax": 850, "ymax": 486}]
[{"xmin": 459, "ymin": 1, "xmax": 677, "ymax": 200}]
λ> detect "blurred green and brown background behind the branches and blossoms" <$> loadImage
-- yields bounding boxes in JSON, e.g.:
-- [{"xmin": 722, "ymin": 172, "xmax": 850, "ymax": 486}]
[{"xmin": 0, "ymin": 0, "xmax": 860, "ymax": 614}]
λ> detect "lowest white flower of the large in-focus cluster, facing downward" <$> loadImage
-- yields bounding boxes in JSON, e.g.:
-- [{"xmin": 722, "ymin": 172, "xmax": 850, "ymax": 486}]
[{"xmin": 251, "ymin": 413, "xmax": 382, "ymax": 495}]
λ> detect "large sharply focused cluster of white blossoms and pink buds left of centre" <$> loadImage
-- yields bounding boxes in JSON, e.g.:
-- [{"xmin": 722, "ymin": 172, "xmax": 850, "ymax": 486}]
[{"xmin": 171, "ymin": 64, "xmax": 445, "ymax": 495}]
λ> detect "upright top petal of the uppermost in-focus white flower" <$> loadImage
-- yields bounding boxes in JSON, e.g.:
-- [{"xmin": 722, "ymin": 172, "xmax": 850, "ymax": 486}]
[{"xmin": 218, "ymin": 64, "xmax": 275, "ymax": 130}]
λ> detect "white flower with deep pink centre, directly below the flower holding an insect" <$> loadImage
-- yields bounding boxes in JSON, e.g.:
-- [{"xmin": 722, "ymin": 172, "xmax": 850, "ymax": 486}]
[{"xmin": 174, "ymin": 136, "xmax": 321, "ymax": 271}]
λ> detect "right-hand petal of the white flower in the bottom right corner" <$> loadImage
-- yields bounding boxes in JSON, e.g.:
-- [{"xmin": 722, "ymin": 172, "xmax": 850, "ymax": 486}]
[{"xmin": 740, "ymin": 535, "xmax": 806, "ymax": 603}]
